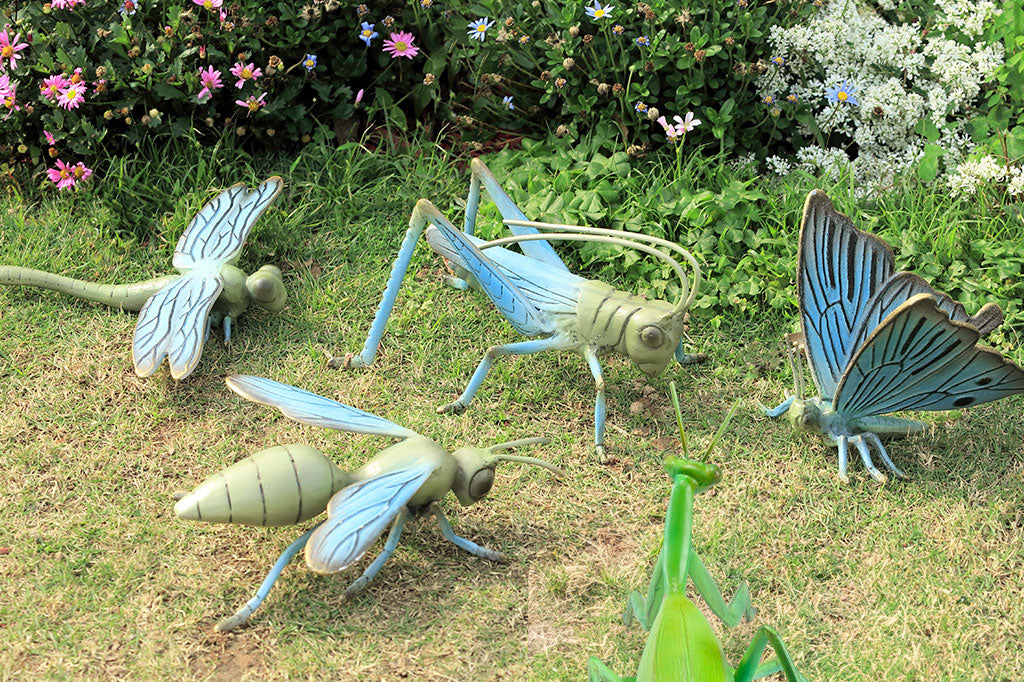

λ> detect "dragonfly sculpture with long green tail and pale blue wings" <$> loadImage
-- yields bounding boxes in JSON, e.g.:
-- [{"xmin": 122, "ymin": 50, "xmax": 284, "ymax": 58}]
[{"xmin": 0, "ymin": 177, "xmax": 287, "ymax": 379}]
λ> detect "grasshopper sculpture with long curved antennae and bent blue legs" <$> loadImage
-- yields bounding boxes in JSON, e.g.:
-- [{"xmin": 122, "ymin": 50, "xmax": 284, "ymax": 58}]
[{"xmin": 331, "ymin": 159, "xmax": 705, "ymax": 460}]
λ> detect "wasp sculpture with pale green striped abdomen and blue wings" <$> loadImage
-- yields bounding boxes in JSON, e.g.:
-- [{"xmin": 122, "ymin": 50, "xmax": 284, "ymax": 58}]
[{"xmin": 174, "ymin": 375, "xmax": 564, "ymax": 632}]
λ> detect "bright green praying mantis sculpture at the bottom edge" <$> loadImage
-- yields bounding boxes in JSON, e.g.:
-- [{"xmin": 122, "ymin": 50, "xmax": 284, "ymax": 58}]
[{"xmin": 588, "ymin": 391, "xmax": 807, "ymax": 682}]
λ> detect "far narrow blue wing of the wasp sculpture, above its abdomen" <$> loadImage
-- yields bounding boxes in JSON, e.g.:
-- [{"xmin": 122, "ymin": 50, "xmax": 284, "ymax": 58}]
[{"xmin": 226, "ymin": 374, "xmax": 418, "ymax": 438}]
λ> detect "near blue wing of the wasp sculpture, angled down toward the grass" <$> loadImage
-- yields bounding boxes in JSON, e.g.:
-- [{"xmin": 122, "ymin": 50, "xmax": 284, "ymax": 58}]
[{"xmin": 306, "ymin": 458, "xmax": 437, "ymax": 574}]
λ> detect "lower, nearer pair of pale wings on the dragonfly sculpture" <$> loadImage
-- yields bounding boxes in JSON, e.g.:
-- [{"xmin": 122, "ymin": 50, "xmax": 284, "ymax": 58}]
[{"xmin": 131, "ymin": 272, "xmax": 223, "ymax": 379}]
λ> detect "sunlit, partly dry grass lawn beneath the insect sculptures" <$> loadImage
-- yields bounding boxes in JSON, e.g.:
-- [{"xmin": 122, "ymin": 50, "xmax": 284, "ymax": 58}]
[{"xmin": 0, "ymin": 140, "xmax": 1024, "ymax": 682}]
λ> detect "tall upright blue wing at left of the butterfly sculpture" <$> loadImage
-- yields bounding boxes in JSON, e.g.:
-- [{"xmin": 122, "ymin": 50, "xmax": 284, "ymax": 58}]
[{"xmin": 797, "ymin": 189, "xmax": 895, "ymax": 397}]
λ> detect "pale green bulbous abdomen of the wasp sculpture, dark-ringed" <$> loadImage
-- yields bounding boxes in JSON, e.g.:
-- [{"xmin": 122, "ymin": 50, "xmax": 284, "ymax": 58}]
[{"xmin": 174, "ymin": 444, "xmax": 351, "ymax": 525}]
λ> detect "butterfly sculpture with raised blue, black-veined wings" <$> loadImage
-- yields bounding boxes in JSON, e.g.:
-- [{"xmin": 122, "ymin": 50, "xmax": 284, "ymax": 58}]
[{"xmin": 765, "ymin": 190, "xmax": 1024, "ymax": 482}]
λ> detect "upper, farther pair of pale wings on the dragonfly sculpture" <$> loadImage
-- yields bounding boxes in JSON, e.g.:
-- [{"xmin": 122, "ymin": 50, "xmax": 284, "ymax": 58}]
[{"xmin": 173, "ymin": 176, "xmax": 284, "ymax": 269}]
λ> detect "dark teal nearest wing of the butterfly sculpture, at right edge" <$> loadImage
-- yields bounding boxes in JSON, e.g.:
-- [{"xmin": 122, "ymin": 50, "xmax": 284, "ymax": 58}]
[{"xmin": 833, "ymin": 294, "xmax": 1024, "ymax": 418}]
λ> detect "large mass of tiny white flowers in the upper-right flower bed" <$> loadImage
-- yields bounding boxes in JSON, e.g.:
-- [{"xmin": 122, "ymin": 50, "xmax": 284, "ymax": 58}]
[{"xmin": 758, "ymin": 0, "xmax": 1004, "ymax": 193}]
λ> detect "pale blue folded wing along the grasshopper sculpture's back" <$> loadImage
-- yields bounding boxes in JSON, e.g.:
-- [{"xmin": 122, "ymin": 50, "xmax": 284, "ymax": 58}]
[{"xmin": 427, "ymin": 225, "xmax": 587, "ymax": 315}]
